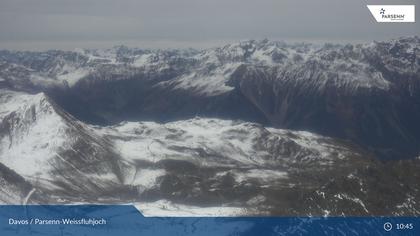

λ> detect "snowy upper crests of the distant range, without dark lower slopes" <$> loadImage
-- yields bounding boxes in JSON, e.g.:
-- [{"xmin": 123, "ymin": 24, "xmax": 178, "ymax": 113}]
[{"xmin": 0, "ymin": 37, "xmax": 420, "ymax": 93}]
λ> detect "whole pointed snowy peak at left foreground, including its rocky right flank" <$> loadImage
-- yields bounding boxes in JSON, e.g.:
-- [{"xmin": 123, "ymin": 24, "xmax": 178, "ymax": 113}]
[{"xmin": 0, "ymin": 90, "xmax": 128, "ymax": 200}]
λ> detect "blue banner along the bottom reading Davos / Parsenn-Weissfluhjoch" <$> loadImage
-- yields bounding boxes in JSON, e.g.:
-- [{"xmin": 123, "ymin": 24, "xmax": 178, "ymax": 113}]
[{"xmin": 0, "ymin": 205, "xmax": 420, "ymax": 236}]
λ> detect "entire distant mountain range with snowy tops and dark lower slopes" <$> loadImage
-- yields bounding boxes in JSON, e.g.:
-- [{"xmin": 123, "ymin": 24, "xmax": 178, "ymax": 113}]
[{"xmin": 0, "ymin": 37, "xmax": 420, "ymax": 159}]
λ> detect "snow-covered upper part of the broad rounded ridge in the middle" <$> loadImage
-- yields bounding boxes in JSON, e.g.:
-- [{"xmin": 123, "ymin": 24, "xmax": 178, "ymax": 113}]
[{"xmin": 98, "ymin": 118, "xmax": 360, "ymax": 167}]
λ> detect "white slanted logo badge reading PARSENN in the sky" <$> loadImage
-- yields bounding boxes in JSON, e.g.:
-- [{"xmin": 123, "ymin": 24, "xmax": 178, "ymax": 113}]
[{"xmin": 367, "ymin": 5, "xmax": 416, "ymax": 22}]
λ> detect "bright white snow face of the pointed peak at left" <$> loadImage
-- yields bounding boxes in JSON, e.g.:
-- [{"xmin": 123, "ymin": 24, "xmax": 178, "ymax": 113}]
[{"xmin": 0, "ymin": 91, "xmax": 68, "ymax": 177}]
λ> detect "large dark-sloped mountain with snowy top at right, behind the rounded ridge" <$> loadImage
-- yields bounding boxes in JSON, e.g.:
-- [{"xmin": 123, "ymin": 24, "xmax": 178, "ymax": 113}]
[{"xmin": 231, "ymin": 38, "xmax": 420, "ymax": 159}]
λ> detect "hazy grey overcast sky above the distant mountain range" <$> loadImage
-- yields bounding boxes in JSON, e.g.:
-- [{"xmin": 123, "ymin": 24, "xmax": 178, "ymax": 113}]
[{"xmin": 0, "ymin": 0, "xmax": 420, "ymax": 50}]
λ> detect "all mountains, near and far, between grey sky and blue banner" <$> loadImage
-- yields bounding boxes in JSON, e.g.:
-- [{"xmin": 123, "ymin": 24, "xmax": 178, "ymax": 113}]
[{"xmin": 0, "ymin": 37, "xmax": 420, "ymax": 215}]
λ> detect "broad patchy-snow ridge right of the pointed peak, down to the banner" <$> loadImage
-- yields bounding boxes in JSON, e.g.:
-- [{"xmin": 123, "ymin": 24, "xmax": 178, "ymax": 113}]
[{"xmin": 96, "ymin": 118, "xmax": 420, "ymax": 216}]
